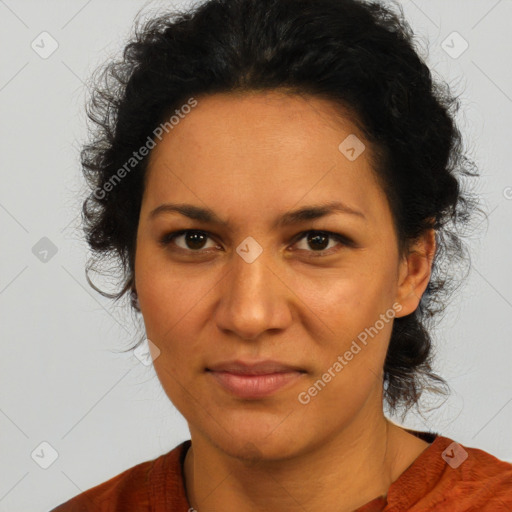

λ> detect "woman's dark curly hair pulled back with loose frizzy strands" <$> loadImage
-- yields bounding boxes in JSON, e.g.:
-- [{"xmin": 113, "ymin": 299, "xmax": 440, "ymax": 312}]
[{"xmin": 81, "ymin": 0, "xmax": 480, "ymax": 411}]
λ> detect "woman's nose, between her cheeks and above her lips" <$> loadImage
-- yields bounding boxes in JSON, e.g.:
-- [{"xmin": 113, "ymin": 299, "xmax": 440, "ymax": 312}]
[{"xmin": 215, "ymin": 247, "xmax": 293, "ymax": 341}]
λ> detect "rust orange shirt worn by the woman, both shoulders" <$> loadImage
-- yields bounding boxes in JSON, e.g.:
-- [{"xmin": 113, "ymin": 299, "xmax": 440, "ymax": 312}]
[{"xmin": 50, "ymin": 429, "xmax": 512, "ymax": 512}]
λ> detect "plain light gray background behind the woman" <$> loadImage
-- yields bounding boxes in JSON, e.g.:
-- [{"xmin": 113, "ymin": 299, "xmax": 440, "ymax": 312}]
[{"xmin": 0, "ymin": 0, "xmax": 512, "ymax": 512}]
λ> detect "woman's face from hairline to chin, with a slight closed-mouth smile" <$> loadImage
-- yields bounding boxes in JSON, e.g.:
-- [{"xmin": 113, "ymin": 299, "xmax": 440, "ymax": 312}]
[{"xmin": 135, "ymin": 91, "xmax": 428, "ymax": 459}]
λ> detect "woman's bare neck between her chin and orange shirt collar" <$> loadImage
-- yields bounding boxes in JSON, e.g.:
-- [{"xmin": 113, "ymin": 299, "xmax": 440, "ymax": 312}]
[{"xmin": 184, "ymin": 411, "xmax": 428, "ymax": 512}]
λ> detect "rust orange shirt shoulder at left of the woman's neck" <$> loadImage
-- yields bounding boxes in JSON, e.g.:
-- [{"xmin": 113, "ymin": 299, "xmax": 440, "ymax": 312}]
[{"xmin": 50, "ymin": 441, "xmax": 190, "ymax": 512}]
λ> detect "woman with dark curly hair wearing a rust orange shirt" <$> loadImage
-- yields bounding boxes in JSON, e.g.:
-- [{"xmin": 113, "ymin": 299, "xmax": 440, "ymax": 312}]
[{"xmin": 50, "ymin": 0, "xmax": 512, "ymax": 512}]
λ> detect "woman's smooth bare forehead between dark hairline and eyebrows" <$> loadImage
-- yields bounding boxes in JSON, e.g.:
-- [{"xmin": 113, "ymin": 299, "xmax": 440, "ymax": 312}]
[{"xmin": 145, "ymin": 92, "xmax": 382, "ymax": 229}]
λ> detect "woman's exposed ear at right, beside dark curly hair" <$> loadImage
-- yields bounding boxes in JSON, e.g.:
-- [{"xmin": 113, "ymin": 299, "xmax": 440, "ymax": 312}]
[{"xmin": 396, "ymin": 229, "xmax": 436, "ymax": 317}]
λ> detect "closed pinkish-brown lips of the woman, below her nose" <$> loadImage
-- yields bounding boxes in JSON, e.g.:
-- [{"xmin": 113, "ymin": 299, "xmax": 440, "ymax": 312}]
[{"xmin": 206, "ymin": 360, "xmax": 306, "ymax": 399}]
